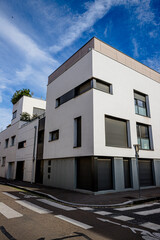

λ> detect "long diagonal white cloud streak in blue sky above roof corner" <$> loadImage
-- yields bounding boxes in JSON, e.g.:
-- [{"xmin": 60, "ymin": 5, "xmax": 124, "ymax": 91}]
[{"xmin": 50, "ymin": 0, "xmax": 137, "ymax": 52}]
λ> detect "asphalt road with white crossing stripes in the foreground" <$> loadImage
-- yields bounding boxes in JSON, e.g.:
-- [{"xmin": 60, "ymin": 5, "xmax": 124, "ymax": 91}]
[{"xmin": 0, "ymin": 185, "xmax": 160, "ymax": 240}]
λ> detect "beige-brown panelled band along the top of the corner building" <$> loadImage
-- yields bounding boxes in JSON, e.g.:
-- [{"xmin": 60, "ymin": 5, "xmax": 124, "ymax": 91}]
[{"xmin": 48, "ymin": 37, "xmax": 160, "ymax": 85}]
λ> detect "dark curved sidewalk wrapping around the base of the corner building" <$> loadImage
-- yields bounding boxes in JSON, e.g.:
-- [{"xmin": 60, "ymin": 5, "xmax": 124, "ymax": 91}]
[{"xmin": 0, "ymin": 178, "xmax": 160, "ymax": 206}]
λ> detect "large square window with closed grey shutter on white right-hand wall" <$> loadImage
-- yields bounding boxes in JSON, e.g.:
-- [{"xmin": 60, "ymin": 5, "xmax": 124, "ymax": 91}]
[{"xmin": 105, "ymin": 116, "xmax": 131, "ymax": 147}]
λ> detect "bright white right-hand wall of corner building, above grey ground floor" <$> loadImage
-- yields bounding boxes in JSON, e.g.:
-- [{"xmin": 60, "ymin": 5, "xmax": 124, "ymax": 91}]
[{"xmin": 92, "ymin": 50, "xmax": 160, "ymax": 159}]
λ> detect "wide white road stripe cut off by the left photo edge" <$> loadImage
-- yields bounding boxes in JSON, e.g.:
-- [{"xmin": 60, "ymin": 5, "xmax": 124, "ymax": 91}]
[{"xmin": 0, "ymin": 202, "xmax": 23, "ymax": 219}]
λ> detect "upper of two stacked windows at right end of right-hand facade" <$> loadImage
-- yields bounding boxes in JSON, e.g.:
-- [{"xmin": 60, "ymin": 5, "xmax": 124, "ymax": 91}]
[{"xmin": 134, "ymin": 91, "xmax": 150, "ymax": 117}]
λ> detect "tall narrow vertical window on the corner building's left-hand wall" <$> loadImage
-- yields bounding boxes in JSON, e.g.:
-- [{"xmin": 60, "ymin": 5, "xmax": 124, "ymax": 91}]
[{"xmin": 74, "ymin": 117, "xmax": 81, "ymax": 147}]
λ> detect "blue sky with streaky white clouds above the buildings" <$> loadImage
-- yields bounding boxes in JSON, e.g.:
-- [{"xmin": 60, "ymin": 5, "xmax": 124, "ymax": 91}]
[{"xmin": 0, "ymin": 0, "xmax": 160, "ymax": 130}]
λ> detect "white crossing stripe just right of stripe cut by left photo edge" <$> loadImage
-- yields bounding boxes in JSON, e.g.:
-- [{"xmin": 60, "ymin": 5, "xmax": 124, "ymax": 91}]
[{"xmin": 16, "ymin": 200, "xmax": 52, "ymax": 214}]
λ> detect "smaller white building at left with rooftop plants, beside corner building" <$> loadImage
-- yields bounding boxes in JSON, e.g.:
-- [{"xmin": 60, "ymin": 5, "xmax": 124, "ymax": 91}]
[{"xmin": 0, "ymin": 96, "xmax": 46, "ymax": 182}]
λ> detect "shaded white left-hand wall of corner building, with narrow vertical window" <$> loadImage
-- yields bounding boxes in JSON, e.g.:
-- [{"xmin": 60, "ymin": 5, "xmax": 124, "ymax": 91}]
[{"xmin": 43, "ymin": 51, "xmax": 93, "ymax": 159}]
